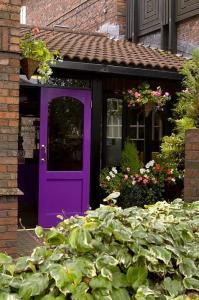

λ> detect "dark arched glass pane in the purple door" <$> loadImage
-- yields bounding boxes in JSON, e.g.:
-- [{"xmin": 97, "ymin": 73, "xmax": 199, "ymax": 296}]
[{"xmin": 47, "ymin": 97, "xmax": 84, "ymax": 171}]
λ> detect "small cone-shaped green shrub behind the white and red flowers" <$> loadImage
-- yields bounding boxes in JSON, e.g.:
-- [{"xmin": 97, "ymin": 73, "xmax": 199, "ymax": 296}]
[{"xmin": 121, "ymin": 141, "xmax": 142, "ymax": 172}]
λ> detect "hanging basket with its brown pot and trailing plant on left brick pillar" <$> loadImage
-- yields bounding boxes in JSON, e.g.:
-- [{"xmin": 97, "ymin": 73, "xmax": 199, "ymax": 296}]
[{"xmin": 20, "ymin": 28, "xmax": 60, "ymax": 82}]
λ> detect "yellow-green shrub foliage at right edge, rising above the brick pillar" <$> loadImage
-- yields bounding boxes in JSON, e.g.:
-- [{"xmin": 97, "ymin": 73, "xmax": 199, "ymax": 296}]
[{"xmin": 161, "ymin": 49, "xmax": 199, "ymax": 167}]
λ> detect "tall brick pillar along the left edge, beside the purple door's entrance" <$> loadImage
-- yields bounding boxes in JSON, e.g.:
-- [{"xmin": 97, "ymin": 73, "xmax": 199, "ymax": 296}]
[{"xmin": 0, "ymin": 0, "xmax": 21, "ymax": 255}]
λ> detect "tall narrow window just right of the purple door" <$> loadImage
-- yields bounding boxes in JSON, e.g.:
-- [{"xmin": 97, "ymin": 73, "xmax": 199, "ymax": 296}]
[{"xmin": 106, "ymin": 98, "xmax": 122, "ymax": 166}]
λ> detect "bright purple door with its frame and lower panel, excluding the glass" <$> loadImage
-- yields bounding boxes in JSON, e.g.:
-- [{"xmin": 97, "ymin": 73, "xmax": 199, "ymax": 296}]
[{"xmin": 38, "ymin": 88, "xmax": 91, "ymax": 227}]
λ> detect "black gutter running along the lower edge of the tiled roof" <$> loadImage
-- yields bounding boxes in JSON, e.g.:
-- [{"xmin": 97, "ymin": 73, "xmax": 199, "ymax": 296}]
[{"xmin": 52, "ymin": 60, "xmax": 182, "ymax": 80}]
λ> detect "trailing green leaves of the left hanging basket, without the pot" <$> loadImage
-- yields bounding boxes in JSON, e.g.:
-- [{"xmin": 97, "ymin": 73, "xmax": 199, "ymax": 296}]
[{"xmin": 20, "ymin": 28, "xmax": 60, "ymax": 83}]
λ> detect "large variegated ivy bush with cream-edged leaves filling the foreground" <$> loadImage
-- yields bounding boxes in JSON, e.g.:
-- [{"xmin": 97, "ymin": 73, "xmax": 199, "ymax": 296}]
[{"xmin": 0, "ymin": 200, "xmax": 199, "ymax": 300}]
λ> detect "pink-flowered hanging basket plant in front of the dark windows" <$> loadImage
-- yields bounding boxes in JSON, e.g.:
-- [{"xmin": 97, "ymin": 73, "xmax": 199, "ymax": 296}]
[{"xmin": 124, "ymin": 82, "xmax": 170, "ymax": 110}]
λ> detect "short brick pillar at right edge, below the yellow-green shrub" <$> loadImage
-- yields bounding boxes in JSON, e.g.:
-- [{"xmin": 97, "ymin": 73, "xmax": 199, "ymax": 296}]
[{"xmin": 184, "ymin": 129, "xmax": 199, "ymax": 202}]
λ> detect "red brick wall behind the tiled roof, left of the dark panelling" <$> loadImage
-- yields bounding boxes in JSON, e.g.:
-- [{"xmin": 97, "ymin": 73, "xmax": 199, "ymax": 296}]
[{"xmin": 24, "ymin": 0, "xmax": 126, "ymax": 35}]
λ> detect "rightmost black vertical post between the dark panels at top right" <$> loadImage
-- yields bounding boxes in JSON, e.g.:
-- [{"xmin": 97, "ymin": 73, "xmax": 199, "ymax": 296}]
[{"xmin": 169, "ymin": 0, "xmax": 177, "ymax": 53}]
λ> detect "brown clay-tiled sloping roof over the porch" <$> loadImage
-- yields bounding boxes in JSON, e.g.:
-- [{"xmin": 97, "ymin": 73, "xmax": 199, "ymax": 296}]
[{"xmin": 21, "ymin": 27, "xmax": 185, "ymax": 71}]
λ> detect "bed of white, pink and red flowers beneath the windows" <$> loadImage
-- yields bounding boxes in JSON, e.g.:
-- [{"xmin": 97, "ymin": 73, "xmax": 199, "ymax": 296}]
[{"xmin": 100, "ymin": 160, "xmax": 183, "ymax": 208}]
